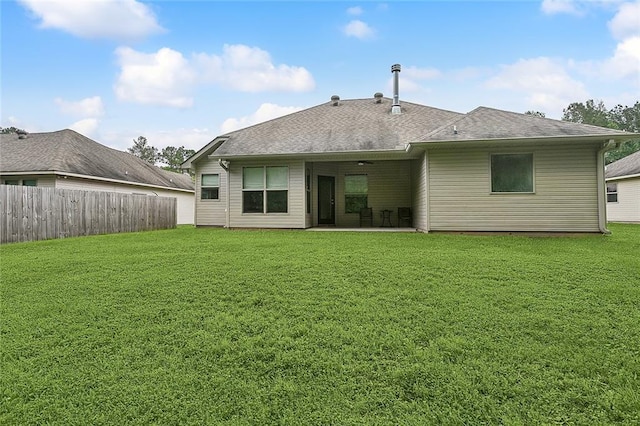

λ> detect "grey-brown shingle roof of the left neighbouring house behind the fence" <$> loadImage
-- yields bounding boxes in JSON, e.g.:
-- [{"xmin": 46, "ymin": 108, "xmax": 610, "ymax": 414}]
[{"xmin": 0, "ymin": 129, "xmax": 194, "ymax": 191}]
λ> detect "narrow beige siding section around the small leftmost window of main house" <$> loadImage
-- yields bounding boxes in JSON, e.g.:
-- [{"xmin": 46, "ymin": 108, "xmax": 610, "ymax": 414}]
[{"xmin": 195, "ymin": 159, "xmax": 227, "ymax": 226}]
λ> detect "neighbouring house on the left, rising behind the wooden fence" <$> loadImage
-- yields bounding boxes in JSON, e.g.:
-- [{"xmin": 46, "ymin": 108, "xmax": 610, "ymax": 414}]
[{"xmin": 0, "ymin": 129, "xmax": 194, "ymax": 224}]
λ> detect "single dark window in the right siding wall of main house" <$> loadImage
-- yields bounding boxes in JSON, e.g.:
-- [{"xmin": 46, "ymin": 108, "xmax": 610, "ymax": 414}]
[{"xmin": 491, "ymin": 154, "xmax": 533, "ymax": 193}]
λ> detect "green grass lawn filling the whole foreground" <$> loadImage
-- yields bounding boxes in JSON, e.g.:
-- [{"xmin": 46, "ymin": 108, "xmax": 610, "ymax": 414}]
[{"xmin": 0, "ymin": 225, "xmax": 640, "ymax": 425}]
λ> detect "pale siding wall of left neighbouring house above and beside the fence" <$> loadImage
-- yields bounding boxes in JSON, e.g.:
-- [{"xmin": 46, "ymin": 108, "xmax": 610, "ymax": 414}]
[{"xmin": 55, "ymin": 176, "xmax": 194, "ymax": 225}]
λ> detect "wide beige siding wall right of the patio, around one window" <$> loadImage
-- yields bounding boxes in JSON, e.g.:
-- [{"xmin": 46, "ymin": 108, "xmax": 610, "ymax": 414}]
[{"xmin": 428, "ymin": 145, "xmax": 599, "ymax": 232}]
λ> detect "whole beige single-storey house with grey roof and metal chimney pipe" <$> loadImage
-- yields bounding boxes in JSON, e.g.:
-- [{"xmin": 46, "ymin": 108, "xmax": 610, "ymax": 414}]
[{"xmin": 183, "ymin": 66, "xmax": 637, "ymax": 232}]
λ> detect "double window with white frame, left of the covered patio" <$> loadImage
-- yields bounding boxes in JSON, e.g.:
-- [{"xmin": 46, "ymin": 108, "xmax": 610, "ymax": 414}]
[{"xmin": 242, "ymin": 166, "xmax": 289, "ymax": 213}]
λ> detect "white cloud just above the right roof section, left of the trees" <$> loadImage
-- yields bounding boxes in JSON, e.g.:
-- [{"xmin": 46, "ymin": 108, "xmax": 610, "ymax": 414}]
[{"xmin": 485, "ymin": 57, "xmax": 589, "ymax": 116}]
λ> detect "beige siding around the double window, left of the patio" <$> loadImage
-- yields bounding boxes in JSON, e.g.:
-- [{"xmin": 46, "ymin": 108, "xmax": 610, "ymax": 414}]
[{"xmin": 229, "ymin": 159, "xmax": 306, "ymax": 228}]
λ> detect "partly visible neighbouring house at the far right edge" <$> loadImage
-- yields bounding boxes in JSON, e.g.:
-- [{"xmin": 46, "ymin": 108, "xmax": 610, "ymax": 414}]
[{"xmin": 605, "ymin": 151, "xmax": 640, "ymax": 223}]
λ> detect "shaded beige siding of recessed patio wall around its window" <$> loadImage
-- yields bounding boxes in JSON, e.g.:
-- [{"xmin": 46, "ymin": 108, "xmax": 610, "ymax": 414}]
[{"xmin": 336, "ymin": 160, "xmax": 411, "ymax": 228}]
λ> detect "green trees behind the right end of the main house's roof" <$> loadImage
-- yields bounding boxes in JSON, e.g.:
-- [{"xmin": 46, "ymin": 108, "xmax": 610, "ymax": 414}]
[{"xmin": 562, "ymin": 99, "xmax": 640, "ymax": 164}]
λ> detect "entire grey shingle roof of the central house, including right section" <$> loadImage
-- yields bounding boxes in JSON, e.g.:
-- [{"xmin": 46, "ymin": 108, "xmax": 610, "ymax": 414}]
[{"xmin": 183, "ymin": 98, "xmax": 634, "ymax": 167}]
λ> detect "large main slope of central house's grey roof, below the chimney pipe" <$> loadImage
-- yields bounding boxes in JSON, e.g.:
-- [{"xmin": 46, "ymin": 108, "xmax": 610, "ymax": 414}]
[{"xmin": 216, "ymin": 98, "xmax": 463, "ymax": 155}]
